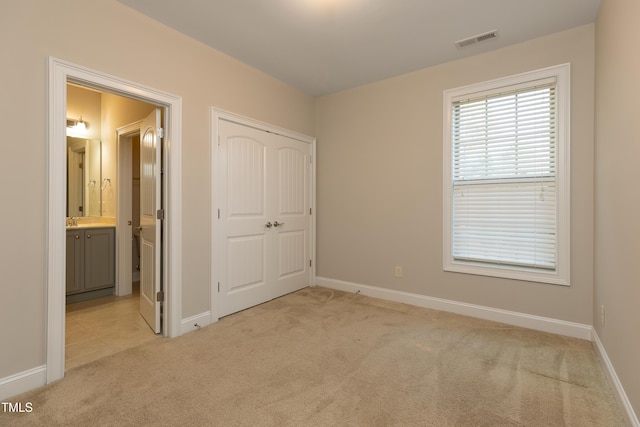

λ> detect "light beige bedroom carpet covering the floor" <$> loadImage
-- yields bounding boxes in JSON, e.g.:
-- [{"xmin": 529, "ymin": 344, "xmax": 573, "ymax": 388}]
[{"xmin": 0, "ymin": 287, "xmax": 624, "ymax": 427}]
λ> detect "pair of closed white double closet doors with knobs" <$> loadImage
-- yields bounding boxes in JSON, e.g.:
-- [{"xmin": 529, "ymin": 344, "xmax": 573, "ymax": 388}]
[{"xmin": 218, "ymin": 120, "xmax": 312, "ymax": 317}]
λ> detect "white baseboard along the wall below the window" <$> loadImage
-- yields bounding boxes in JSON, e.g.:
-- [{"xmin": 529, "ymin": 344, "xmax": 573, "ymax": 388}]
[{"xmin": 315, "ymin": 277, "xmax": 593, "ymax": 341}]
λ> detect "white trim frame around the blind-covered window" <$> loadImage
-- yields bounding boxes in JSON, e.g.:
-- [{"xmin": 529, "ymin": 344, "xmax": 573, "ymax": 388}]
[{"xmin": 443, "ymin": 63, "xmax": 571, "ymax": 286}]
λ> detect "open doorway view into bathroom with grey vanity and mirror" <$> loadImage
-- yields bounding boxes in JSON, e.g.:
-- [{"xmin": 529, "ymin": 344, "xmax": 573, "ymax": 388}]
[{"xmin": 65, "ymin": 83, "xmax": 162, "ymax": 370}]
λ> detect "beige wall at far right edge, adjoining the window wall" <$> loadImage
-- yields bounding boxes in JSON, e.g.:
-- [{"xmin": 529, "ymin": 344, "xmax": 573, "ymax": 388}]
[{"xmin": 594, "ymin": 0, "xmax": 640, "ymax": 415}]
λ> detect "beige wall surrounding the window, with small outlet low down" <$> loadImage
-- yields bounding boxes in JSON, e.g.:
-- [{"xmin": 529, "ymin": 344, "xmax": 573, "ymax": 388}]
[{"xmin": 316, "ymin": 25, "xmax": 594, "ymax": 325}]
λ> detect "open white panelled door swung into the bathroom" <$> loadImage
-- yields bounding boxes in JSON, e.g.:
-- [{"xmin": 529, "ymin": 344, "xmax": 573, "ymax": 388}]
[{"xmin": 140, "ymin": 108, "xmax": 162, "ymax": 333}]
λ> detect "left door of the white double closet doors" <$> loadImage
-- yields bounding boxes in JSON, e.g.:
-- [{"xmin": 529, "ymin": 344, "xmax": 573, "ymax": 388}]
[{"xmin": 219, "ymin": 121, "xmax": 270, "ymax": 316}]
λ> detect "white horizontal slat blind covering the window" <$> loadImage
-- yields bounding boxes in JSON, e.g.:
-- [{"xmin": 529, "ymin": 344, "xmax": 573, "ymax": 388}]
[{"xmin": 451, "ymin": 78, "xmax": 558, "ymax": 270}]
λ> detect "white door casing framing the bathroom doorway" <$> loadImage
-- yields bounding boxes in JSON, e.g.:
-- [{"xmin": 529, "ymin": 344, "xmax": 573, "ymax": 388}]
[{"xmin": 46, "ymin": 57, "xmax": 182, "ymax": 383}]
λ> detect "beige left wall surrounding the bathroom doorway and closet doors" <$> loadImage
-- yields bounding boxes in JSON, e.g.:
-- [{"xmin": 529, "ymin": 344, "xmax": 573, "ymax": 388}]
[{"xmin": 0, "ymin": 0, "xmax": 314, "ymax": 378}]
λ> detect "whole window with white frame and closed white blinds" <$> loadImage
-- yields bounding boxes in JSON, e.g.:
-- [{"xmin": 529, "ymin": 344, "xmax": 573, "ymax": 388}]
[{"xmin": 444, "ymin": 64, "xmax": 569, "ymax": 285}]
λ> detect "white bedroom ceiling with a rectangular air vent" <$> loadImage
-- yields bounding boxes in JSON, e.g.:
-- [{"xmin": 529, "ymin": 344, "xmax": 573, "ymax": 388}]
[{"xmin": 118, "ymin": 0, "xmax": 600, "ymax": 96}]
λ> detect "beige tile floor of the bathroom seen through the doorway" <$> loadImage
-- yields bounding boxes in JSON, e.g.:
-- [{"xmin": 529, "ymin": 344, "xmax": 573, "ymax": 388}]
[{"xmin": 65, "ymin": 283, "xmax": 161, "ymax": 370}]
